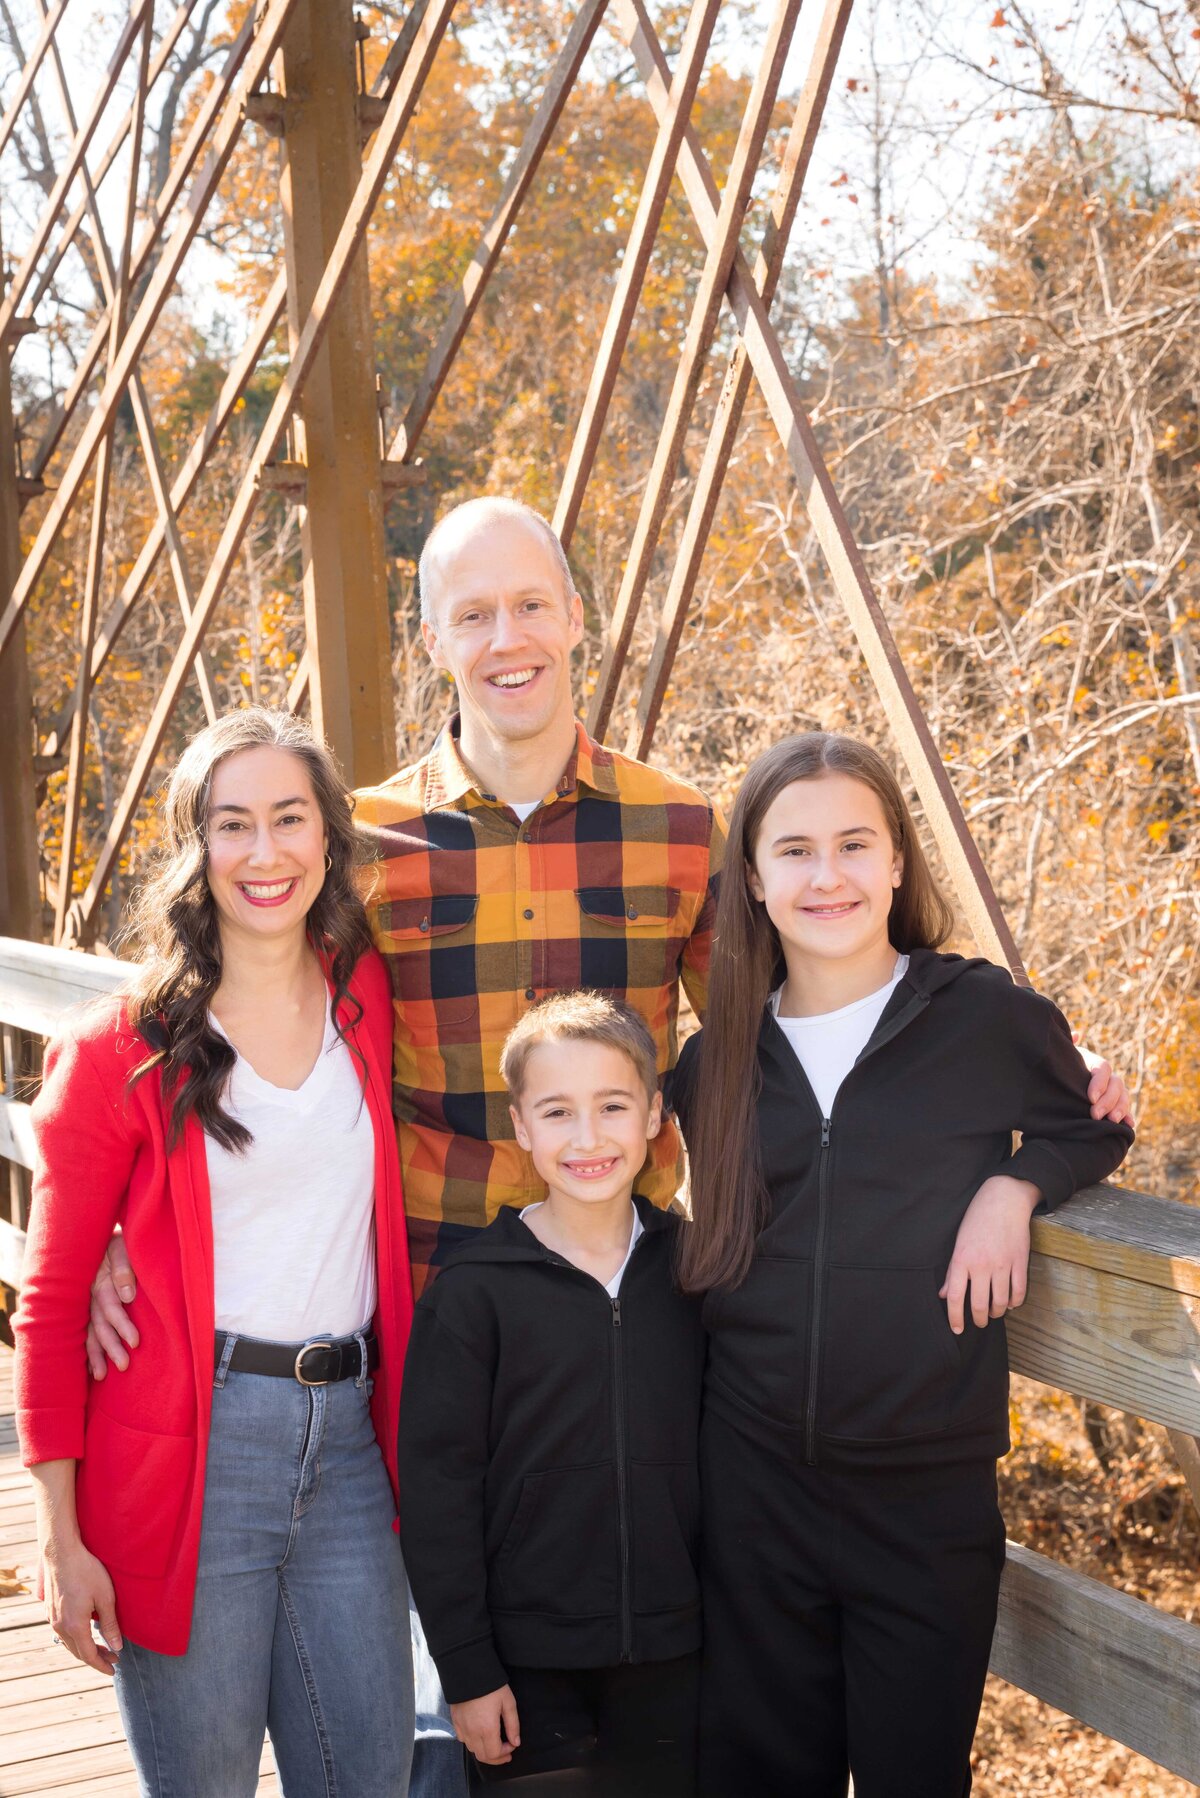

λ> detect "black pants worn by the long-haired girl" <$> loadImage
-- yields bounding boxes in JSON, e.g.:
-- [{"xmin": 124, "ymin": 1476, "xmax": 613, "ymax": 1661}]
[{"xmin": 700, "ymin": 1409, "xmax": 1004, "ymax": 1798}]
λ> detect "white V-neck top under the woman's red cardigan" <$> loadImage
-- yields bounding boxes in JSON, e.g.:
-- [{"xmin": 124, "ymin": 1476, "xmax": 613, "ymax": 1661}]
[{"xmin": 205, "ymin": 1018, "xmax": 376, "ymax": 1343}]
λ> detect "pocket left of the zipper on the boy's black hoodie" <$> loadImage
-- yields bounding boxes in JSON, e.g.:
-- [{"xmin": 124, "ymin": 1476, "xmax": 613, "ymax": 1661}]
[{"xmin": 493, "ymin": 1462, "xmax": 619, "ymax": 1616}]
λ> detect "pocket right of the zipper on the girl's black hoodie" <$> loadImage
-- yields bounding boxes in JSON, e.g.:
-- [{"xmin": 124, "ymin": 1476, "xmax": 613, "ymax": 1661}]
[{"xmin": 817, "ymin": 1268, "xmax": 959, "ymax": 1442}]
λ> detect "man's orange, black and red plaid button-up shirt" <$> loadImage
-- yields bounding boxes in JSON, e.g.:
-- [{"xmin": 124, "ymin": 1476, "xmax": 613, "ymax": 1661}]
[{"xmin": 354, "ymin": 725, "xmax": 723, "ymax": 1293}]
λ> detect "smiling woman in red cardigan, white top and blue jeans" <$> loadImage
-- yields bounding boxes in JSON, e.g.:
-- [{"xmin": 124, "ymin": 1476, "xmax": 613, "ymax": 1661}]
[{"xmin": 14, "ymin": 708, "xmax": 412, "ymax": 1798}]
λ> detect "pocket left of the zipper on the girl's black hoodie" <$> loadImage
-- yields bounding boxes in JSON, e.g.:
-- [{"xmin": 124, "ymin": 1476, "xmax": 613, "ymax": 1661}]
[{"xmin": 703, "ymin": 1255, "xmax": 813, "ymax": 1429}]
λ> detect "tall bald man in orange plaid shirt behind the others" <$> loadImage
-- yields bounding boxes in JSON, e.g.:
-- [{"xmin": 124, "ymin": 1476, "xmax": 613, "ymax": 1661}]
[{"xmin": 88, "ymin": 498, "xmax": 1126, "ymax": 1798}]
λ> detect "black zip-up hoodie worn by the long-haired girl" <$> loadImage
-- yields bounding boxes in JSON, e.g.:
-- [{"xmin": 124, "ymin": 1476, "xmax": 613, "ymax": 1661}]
[{"xmin": 669, "ymin": 949, "xmax": 1133, "ymax": 1467}]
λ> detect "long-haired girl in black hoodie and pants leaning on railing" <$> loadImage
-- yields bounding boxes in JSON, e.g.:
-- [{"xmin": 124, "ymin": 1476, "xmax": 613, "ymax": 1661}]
[{"xmin": 675, "ymin": 732, "xmax": 1132, "ymax": 1798}]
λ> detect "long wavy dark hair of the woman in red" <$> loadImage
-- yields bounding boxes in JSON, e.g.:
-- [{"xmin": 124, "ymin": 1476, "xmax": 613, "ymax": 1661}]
[{"xmin": 121, "ymin": 705, "xmax": 371, "ymax": 1151}]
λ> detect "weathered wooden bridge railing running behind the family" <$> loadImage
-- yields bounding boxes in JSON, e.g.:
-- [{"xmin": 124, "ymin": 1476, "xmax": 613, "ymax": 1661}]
[{"xmin": 0, "ymin": 937, "xmax": 1200, "ymax": 1784}]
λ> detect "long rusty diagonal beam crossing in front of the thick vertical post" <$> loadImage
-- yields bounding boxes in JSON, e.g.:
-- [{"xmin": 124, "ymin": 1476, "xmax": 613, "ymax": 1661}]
[{"xmin": 79, "ymin": 0, "xmax": 455, "ymax": 928}]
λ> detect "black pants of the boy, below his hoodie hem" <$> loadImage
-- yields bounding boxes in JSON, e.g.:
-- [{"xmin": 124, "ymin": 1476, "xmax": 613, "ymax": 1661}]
[{"xmin": 468, "ymin": 1654, "xmax": 700, "ymax": 1798}]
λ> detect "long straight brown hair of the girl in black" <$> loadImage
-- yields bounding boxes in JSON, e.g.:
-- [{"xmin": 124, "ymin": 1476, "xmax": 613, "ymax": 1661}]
[{"xmin": 678, "ymin": 730, "xmax": 954, "ymax": 1293}]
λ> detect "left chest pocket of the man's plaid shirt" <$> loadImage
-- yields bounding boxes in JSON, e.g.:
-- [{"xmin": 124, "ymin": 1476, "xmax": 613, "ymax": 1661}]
[{"xmin": 378, "ymin": 894, "xmax": 479, "ymax": 1041}]
